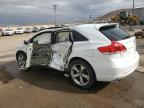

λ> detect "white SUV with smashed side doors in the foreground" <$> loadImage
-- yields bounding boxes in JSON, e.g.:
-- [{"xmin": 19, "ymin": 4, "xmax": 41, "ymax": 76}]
[{"xmin": 16, "ymin": 23, "xmax": 139, "ymax": 88}]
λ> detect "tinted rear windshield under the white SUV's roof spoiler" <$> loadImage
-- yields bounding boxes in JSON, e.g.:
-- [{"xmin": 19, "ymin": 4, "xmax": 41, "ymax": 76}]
[{"xmin": 100, "ymin": 26, "xmax": 130, "ymax": 41}]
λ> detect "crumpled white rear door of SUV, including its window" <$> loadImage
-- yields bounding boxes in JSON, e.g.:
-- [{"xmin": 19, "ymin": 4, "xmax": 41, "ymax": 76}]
[{"xmin": 49, "ymin": 30, "xmax": 73, "ymax": 71}]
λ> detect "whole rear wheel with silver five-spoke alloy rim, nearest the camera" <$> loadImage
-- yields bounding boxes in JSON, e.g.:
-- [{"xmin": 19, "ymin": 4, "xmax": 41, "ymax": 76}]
[{"xmin": 69, "ymin": 60, "xmax": 96, "ymax": 89}]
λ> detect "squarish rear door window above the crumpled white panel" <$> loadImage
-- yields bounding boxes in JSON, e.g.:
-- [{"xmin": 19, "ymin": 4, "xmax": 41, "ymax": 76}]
[{"xmin": 56, "ymin": 32, "xmax": 70, "ymax": 42}]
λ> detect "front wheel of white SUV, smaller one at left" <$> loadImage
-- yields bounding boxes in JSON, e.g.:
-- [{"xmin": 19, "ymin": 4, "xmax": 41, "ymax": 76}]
[{"xmin": 17, "ymin": 53, "xmax": 27, "ymax": 71}]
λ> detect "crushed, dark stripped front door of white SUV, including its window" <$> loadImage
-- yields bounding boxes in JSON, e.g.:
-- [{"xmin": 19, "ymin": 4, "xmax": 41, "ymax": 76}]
[{"xmin": 30, "ymin": 33, "xmax": 53, "ymax": 66}]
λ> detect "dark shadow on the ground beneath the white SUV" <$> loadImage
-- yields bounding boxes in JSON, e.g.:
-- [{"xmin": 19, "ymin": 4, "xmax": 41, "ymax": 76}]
[{"xmin": 0, "ymin": 61, "xmax": 109, "ymax": 94}]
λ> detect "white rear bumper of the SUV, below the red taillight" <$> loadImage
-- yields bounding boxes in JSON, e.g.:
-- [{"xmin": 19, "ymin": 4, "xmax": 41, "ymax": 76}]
[{"xmin": 91, "ymin": 53, "xmax": 139, "ymax": 81}]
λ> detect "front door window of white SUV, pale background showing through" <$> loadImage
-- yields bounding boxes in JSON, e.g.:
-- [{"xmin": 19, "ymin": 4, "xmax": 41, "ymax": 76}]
[{"xmin": 33, "ymin": 33, "xmax": 51, "ymax": 44}]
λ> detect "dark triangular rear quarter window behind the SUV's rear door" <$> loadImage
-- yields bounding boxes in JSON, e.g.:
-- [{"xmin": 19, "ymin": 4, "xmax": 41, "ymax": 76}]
[{"xmin": 72, "ymin": 31, "xmax": 88, "ymax": 42}]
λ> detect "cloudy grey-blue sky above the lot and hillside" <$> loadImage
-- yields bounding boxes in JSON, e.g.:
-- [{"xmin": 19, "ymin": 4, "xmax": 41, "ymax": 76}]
[{"xmin": 0, "ymin": 0, "xmax": 144, "ymax": 25}]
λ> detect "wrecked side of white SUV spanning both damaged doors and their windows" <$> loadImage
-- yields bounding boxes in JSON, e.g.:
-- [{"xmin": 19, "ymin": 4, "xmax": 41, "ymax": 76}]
[{"xmin": 26, "ymin": 31, "xmax": 73, "ymax": 71}]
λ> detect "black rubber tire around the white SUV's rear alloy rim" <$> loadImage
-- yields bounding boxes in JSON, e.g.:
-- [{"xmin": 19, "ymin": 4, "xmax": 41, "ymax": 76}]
[{"xmin": 68, "ymin": 60, "xmax": 96, "ymax": 89}]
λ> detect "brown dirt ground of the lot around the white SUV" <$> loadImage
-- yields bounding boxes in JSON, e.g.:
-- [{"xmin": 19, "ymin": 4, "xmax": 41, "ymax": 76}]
[{"xmin": 0, "ymin": 34, "xmax": 144, "ymax": 108}]
